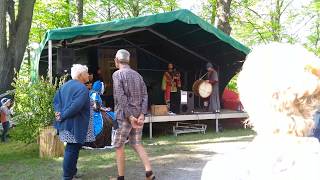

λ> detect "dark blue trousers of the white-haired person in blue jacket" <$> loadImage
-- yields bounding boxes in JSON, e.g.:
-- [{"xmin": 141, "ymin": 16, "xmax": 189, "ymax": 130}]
[{"xmin": 63, "ymin": 143, "xmax": 82, "ymax": 180}]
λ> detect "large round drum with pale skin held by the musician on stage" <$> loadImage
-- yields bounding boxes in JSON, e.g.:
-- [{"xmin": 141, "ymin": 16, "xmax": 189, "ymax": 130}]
[{"xmin": 192, "ymin": 79, "xmax": 213, "ymax": 98}]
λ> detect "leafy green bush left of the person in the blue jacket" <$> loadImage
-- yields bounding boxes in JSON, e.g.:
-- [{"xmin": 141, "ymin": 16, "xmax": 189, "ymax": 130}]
[{"xmin": 11, "ymin": 75, "xmax": 57, "ymax": 143}]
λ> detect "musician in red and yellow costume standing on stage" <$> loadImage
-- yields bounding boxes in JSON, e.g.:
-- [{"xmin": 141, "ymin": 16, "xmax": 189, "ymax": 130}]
[{"xmin": 161, "ymin": 63, "xmax": 181, "ymax": 108}]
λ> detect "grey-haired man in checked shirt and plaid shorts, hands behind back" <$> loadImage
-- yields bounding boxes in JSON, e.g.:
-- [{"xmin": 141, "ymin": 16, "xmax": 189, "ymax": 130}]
[{"xmin": 112, "ymin": 49, "xmax": 155, "ymax": 180}]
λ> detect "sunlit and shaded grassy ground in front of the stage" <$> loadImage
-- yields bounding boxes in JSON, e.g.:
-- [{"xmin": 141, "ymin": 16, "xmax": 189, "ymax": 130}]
[{"xmin": 0, "ymin": 130, "xmax": 254, "ymax": 180}]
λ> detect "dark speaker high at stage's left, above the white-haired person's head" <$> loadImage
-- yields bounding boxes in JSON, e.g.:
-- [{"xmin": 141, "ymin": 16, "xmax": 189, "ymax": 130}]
[{"xmin": 56, "ymin": 48, "xmax": 75, "ymax": 75}]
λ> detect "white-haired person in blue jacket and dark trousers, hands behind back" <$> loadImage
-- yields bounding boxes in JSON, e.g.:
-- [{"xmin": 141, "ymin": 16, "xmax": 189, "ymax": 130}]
[{"xmin": 54, "ymin": 64, "xmax": 90, "ymax": 180}]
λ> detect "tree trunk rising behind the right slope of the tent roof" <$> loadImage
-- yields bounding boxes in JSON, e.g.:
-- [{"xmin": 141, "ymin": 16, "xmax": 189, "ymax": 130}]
[{"xmin": 215, "ymin": 0, "xmax": 232, "ymax": 35}]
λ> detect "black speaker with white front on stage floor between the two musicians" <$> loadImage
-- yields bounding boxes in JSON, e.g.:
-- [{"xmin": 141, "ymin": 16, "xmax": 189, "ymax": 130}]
[{"xmin": 170, "ymin": 91, "xmax": 194, "ymax": 114}]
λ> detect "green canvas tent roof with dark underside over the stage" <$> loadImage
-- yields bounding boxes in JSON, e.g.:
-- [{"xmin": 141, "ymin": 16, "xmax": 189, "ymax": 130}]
[{"xmin": 32, "ymin": 10, "xmax": 250, "ymax": 91}]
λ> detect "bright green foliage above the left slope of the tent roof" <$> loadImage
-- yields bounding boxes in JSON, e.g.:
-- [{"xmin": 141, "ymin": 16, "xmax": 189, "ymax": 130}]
[{"xmin": 30, "ymin": 0, "xmax": 178, "ymax": 42}]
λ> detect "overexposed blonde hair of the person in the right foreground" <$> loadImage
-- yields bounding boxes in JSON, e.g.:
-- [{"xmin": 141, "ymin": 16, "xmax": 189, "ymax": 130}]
[{"xmin": 238, "ymin": 43, "xmax": 320, "ymax": 136}]
